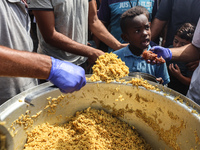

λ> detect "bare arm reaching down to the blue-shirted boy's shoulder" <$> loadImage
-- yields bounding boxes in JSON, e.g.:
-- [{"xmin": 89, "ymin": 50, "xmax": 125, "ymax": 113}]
[{"xmin": 88, "ymin": 0, "xmax": 127, "ymax": 50}]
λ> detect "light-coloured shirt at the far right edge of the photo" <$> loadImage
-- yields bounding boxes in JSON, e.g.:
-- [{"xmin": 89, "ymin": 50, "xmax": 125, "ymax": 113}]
[{"xmin": 186, "ymin": 19, "xmax": 200, "ymax": 105}]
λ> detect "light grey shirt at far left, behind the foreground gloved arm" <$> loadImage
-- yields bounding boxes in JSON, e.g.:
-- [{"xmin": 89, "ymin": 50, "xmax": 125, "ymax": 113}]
[{"xmin": 0, "ymin": 0, "xmax": 37, "ymax": 104}]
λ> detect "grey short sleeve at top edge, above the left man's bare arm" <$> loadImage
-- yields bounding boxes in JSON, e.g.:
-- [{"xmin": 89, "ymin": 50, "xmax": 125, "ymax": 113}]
[{"xmin": 28, "ymin": 0, "xmax": 53, "ymax": 10}]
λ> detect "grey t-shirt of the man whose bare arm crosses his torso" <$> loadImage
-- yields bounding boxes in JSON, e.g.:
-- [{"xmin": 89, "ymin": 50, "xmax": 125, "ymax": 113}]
[{"xmin": 28, "ymin": 0, "xmax": 89, "ymax": 65}]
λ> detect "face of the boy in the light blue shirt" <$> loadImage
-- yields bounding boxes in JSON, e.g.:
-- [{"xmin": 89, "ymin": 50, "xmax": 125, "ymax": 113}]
[{"xmin": 122, "ymin": 14, "xmax": 151, "ymax": 50}]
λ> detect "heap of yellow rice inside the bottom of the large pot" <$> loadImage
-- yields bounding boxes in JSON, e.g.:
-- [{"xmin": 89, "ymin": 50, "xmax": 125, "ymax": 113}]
[{"xmin": 24, "ymin": 108, "xmax": 151, "ymax": 150}]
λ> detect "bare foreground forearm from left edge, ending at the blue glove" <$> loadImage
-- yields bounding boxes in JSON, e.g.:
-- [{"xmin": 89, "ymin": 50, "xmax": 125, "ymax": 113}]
[{"xmin": 0, "ymin": 46, "xmax": 51, "ymax": 79}]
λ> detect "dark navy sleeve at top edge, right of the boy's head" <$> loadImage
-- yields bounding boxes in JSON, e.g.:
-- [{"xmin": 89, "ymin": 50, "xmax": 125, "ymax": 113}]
[{"xmin": 155, "ymin": 0, "xmax": 173, "ymax": 21}]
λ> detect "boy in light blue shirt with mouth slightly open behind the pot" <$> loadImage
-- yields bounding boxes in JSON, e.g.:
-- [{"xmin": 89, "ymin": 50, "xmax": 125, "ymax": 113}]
[{"xmin": 114, "ymin": 6, "xmax": 170, "ymax": 85}]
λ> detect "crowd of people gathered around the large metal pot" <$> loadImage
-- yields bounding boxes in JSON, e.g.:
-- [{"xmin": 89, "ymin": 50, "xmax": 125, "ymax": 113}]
[{"xmin": 0, "ymin": 0, "xmax": 200, "ymax": 104}]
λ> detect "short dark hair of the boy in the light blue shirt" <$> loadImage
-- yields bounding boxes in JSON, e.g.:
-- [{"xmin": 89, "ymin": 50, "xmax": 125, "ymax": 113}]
[{"xmin": 120, "ymin": 6, "xmax": 149, "ymax": 32}]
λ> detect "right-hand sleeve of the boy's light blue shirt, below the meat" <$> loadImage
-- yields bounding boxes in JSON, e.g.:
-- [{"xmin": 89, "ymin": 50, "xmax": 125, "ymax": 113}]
[{"xmin": 156, "ymin": 63, "xmax": 170, "ymax": 85}]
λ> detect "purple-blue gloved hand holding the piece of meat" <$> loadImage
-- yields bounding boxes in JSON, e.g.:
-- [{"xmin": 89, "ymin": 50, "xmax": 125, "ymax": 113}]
[{"xmin": 150, "ymin": 46, "xmax": 172, "ymax": 61}]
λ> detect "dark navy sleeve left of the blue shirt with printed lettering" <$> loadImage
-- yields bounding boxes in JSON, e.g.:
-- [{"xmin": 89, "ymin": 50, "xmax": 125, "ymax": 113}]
[{"xmin": 98, "ymin": 0, "xmax": 110, "ymax": 23}]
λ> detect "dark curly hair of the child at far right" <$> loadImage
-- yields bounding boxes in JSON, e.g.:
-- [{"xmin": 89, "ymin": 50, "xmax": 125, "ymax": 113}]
[{"xmin": 175, "ymin": 23, "xmax": 195, "ymax": 42}]
